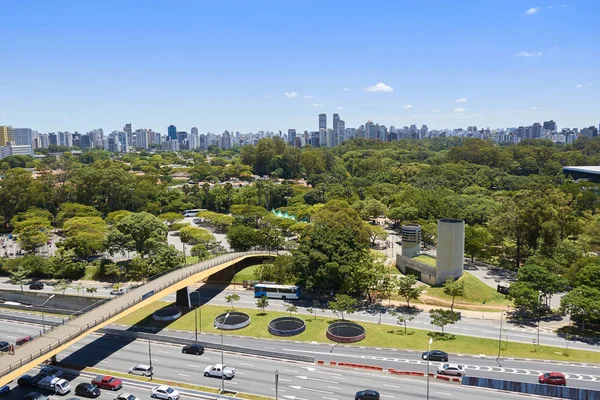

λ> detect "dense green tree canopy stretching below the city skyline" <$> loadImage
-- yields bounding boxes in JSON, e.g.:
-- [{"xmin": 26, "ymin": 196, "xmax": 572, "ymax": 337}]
[{"xmin": 0, "ymin": 137, "xmax": 600, "ymax": 328}]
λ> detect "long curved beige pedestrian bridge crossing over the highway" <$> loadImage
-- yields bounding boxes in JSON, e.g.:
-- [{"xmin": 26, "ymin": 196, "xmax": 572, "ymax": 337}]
[{"xmin": 0, "ymin": 251, "xmax": 275, "ymax": 387}]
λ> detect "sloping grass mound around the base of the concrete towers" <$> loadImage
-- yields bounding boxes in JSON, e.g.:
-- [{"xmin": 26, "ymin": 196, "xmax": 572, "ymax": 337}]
[{"xmin": 426, "ymin": 272, "xmax": 513, "ymax": 306}]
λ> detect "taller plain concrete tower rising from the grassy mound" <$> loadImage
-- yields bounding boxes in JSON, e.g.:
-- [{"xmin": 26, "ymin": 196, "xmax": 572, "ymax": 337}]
[{"xmin": 435, "ymin": 219, "xmax": 465, "ymax": 285}]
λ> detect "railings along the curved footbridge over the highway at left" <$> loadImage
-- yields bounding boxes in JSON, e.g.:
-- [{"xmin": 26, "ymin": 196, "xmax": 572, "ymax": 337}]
[{"xmin": 0, "ymin": 250, "xmax": 275, "ymax": 376}]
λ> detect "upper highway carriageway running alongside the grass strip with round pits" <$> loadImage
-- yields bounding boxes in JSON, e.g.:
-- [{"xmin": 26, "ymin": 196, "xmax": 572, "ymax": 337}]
[{"xmin": 0, "ymin": 322, "xmax": 600, "ymax": 389}]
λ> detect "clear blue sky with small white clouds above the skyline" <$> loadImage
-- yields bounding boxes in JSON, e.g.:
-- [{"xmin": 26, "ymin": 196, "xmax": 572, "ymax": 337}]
[{"xmin": 0, "ymin": 0, "xmax": 600, "ymax": 133}]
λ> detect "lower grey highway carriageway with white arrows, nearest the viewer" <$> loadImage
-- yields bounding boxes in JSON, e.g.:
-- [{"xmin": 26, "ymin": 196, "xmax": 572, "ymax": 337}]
[{"xmin": 1, "ymin": 324, "xmax": 544, "ymax": 400}]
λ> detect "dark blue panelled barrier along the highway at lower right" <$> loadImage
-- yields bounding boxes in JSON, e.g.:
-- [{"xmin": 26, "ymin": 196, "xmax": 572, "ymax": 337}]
[{"xmin": 462, "ymin": 376, "xmax": 600, "ymax": 400}]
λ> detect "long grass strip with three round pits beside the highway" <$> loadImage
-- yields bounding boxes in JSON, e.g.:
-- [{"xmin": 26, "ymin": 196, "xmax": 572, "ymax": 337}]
[{"xmin": 117, "ymin": 302, "xmax": 600, "ymax": 363}]
